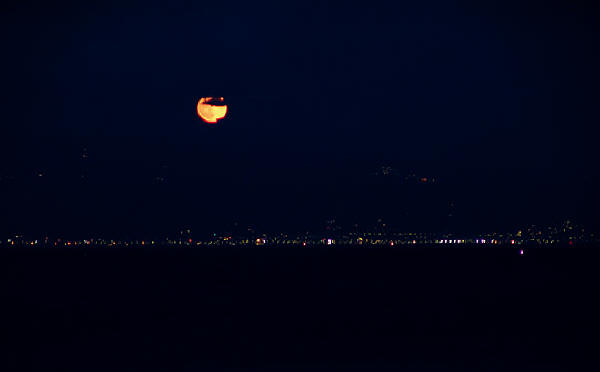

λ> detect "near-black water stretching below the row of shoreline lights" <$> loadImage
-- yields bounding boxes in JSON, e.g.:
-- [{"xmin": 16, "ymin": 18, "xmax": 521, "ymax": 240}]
[{"xmin": 0, "ymin": 247, "xmax": 600, "ymax": 371}]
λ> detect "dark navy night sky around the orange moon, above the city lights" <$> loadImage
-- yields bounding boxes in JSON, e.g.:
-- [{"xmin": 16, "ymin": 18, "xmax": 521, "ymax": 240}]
[{"xmin": 0, "ymin": 0, "xmax": 600, "ymax": 236}]
